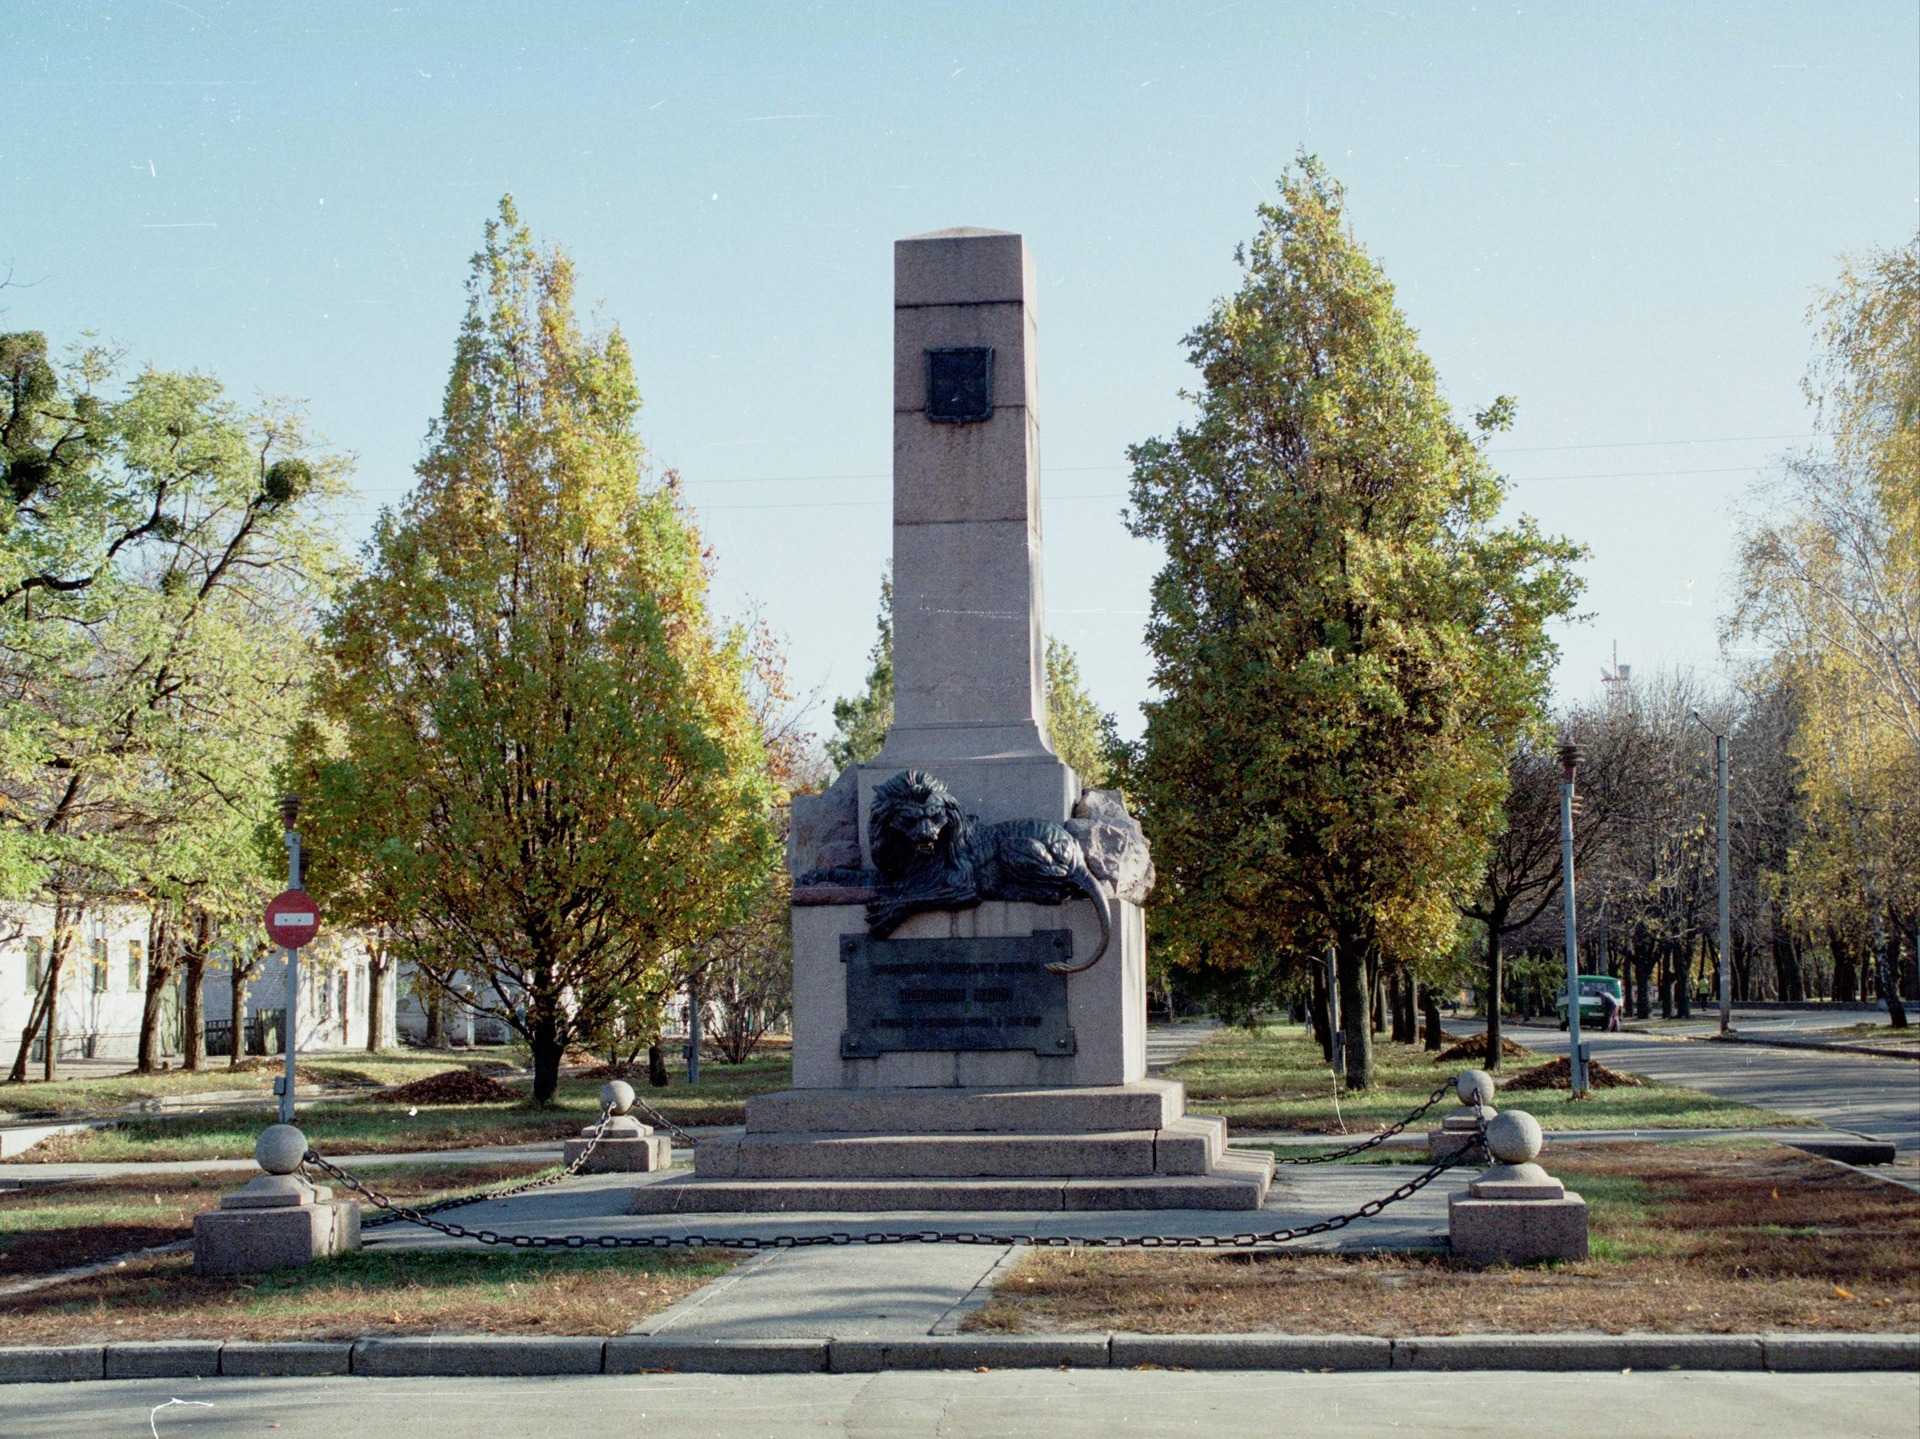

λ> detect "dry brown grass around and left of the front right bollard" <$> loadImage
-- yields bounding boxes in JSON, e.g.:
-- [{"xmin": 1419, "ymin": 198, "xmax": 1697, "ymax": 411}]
[{"xmin": 966, "ymin": 1141, "xmax": 1920, "ymax": 1335}]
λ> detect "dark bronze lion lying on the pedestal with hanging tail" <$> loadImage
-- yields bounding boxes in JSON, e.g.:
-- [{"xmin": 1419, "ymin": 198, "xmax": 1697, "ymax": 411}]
[{"xmin": 866, "ymin": 770, "xmax": 1114, "ymax": 974}]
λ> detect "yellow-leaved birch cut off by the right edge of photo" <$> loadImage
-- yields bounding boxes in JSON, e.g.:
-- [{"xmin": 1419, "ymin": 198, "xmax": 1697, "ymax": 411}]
[{"xmin": 1728, "ymin": 238, "xmax": 1920, "ymax": 1028}]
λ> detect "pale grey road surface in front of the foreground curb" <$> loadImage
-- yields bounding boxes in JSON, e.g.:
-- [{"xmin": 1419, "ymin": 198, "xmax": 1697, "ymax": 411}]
[{"xmin": 0, "ymin": 1370, "xmax": 1920, "ymax": 1439}]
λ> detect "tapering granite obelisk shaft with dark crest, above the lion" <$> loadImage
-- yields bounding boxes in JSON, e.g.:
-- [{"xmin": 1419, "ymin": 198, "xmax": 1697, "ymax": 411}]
[{"xmin": 860, "ymin": 231, "xmax": 1079, "ymax": 820}]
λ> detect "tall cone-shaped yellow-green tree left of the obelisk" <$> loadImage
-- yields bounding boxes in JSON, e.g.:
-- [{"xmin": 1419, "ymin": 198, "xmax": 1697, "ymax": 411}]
[{"xmin": 294, "ymin": 198, "xmax": 776, "ymax": 1101}]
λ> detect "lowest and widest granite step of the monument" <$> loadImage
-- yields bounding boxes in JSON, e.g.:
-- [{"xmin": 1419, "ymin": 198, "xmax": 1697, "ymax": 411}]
[{"xmin": 628, "ymin": 1155, "xmax": 1271, "ymax": 1214}]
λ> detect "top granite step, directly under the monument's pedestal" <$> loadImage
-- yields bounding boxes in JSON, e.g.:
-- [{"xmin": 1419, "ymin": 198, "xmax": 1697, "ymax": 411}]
[{"xmin": 747, "ymin": 1080, "xmax": 1187, "ymax": 1134}]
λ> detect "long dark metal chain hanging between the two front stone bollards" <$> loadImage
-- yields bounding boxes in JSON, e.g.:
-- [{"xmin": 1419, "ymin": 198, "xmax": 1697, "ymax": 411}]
[{"xmin": 305, "ymin": 1120, "xmax": 1486, "ymax": 1251}]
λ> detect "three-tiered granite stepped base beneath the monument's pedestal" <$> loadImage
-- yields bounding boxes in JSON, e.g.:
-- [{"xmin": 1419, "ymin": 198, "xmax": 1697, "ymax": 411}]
[{"xmin": 634, "ymin": 1080, "xmax": 1273, "ymax": 1214}]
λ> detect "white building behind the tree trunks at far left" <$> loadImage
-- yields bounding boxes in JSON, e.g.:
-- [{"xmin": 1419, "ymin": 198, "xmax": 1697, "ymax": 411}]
[{"xmin": 0, "ymin": 903, "xmax": 397, "ymax": 1061}]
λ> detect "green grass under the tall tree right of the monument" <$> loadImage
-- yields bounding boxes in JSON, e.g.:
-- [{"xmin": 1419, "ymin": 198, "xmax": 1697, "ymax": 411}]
[{"xmin": 1167, "ymin": 1024, "xmax": 1805, "ymax": 1135}]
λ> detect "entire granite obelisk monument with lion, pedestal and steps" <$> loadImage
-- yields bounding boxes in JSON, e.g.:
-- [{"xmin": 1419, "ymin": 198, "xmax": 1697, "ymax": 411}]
[{"xmin": 634, "ymin": 229, "xmax": 1273, "ymax": 1212}]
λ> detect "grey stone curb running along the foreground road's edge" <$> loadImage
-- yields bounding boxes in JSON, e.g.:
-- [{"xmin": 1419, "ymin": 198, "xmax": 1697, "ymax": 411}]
[{"xmin": 0, "ymin": 1333, "xmax": 1920, "ymax": 1383}]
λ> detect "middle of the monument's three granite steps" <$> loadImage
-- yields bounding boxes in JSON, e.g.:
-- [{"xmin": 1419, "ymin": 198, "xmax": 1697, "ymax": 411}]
[{"xmin": 693, "ymin": 1130, "xmax": 1159, "ymax": 1180}]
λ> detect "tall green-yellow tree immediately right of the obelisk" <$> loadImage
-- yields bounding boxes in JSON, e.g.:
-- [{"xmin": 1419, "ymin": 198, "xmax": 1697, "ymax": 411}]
[{"xmin": 1129, "ymin": 158, "xmax": 1578, "ymax": 1087}]
